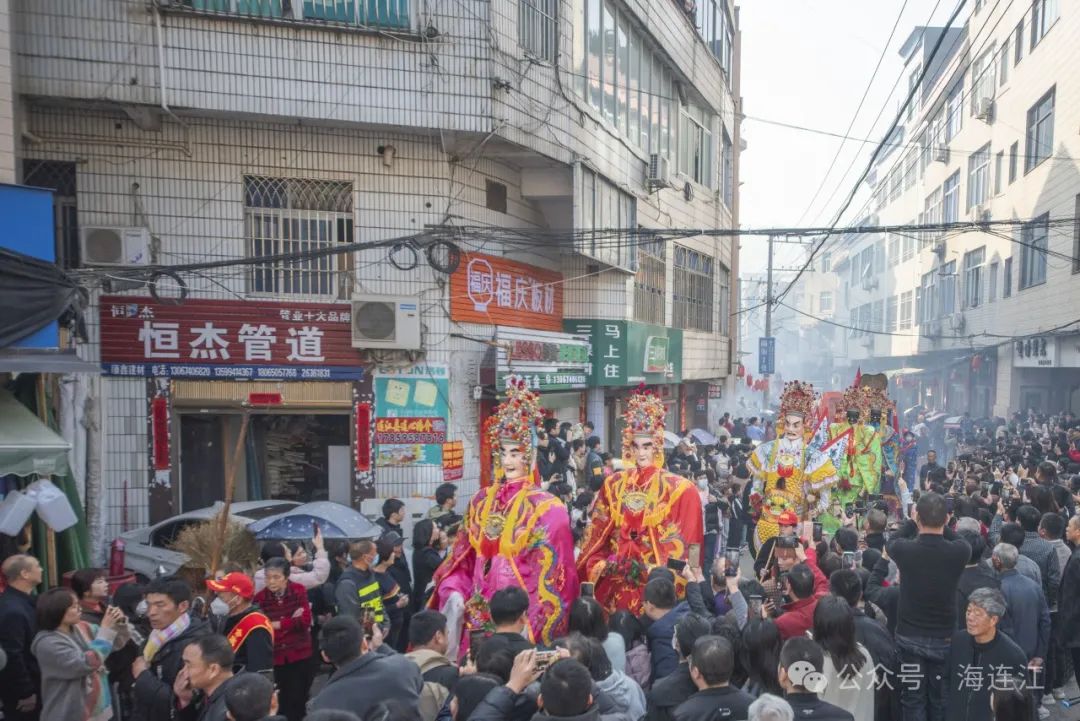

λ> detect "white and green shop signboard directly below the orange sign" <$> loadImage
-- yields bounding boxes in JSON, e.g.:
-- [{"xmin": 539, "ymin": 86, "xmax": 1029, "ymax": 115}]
[{"xmin": 481, "ymin": 328, "xmax": 590, "ymax": 393}]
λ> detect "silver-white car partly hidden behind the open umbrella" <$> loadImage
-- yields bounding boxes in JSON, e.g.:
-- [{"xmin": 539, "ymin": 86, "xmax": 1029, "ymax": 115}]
[{"xmin": 120, "ymin": 501, "xmax": 300, "ymax": 582}]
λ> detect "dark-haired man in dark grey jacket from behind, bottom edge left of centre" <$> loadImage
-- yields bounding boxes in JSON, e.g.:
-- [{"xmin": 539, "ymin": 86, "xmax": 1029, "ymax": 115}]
[{"xmin": 308, "ymin": 616, "xmax": 423, "ymax": 718}]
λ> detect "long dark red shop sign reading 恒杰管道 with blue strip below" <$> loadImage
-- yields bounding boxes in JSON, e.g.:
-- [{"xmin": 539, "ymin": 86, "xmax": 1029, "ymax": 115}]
[{"xmin": 100, "ymin": 296, "xmax": 363, "ymax": 381}]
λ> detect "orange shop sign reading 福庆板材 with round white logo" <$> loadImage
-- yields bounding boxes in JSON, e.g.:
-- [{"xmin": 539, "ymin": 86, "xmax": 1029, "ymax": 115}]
[{"xmin": 450, "ymin": 253, "xmax": 563, "ymax": 330}]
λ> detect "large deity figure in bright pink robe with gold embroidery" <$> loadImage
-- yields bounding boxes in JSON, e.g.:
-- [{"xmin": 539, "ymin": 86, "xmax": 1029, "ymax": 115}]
[{"xmin": 429, "ymin": 379, "xmax": 578, "ymax": 657}]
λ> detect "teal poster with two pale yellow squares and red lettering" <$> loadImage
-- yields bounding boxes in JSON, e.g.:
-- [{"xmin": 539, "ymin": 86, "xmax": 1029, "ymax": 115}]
[{"xmin": 373, "ymin": 363, "xmax": 450, "ymax": 466}]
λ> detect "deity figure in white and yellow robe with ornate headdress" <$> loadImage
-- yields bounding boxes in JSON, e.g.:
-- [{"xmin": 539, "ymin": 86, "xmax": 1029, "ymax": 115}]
[{"xmin": 748, "ymin": 381, "xmax": 845, "ymax": 548}]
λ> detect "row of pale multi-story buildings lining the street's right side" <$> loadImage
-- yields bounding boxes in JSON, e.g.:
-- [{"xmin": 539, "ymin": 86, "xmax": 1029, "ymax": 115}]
[{"xmin": 794, "ymin": 0, "xmax": 1080, "ymax": 418}]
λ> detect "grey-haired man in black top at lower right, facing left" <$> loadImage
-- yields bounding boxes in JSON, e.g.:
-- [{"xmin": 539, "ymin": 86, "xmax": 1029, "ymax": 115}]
[{"xmin": 945, "ymin": 588, "xmax": 1027, "ymax": 721}]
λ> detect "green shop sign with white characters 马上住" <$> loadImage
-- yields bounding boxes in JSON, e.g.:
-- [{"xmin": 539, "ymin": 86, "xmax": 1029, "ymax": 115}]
[{"xmin": 563, "ymin": 319, "xmax": 683, "ymax": 386}]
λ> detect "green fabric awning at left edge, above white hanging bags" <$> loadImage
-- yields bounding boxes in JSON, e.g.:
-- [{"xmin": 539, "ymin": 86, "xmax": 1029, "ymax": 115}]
[{"xmin": 0, "ymin": 391, "xmax": 70, "ymax": 476}]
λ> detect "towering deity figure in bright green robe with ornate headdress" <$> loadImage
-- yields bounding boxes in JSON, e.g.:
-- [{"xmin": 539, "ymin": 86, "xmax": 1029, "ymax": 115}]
[{"xmin": 828, "ymin": 385, "xmax": 883, "ymax": 505}]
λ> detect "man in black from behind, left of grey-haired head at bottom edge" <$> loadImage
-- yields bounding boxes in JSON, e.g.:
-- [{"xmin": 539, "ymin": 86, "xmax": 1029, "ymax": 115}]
[{"xmin": 675, "ymin": 636, "xmax": 754, "ymax": 721}]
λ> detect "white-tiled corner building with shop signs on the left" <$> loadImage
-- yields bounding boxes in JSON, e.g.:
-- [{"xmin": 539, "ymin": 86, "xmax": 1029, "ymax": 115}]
[{"xmin": 8, "ymin": 0, "xmax": 740, "ymax": 546}]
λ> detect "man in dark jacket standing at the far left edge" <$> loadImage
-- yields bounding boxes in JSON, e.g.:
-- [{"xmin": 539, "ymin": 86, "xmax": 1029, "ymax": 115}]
[{"xmin": 0, "ymin": 554, "xmax": 41, "ymax": 721}]
